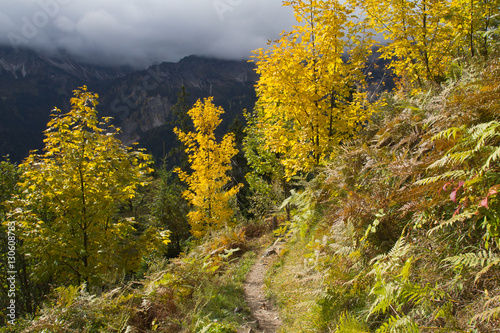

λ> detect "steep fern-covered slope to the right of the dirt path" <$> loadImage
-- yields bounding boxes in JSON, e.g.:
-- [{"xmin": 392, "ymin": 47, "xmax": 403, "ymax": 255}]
[{"xmin": 260, "ymin": 55, "xmax": 500, "ymax": 333}]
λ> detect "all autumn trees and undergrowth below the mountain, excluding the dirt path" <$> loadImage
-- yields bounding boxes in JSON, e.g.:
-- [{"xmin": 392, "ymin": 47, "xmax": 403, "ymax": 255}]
[{"xmin": 0, "ymin": 0, "xmax": 500, "ymax": 333}]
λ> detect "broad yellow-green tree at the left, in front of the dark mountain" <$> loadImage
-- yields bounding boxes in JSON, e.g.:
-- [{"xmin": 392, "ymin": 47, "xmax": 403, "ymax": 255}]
[{"xmin": 11, "ymin": 86, "xmax": 168, "ymax": 285}]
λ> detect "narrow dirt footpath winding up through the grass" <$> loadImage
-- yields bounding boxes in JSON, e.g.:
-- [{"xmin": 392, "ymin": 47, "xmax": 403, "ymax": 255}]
[{"xmin": 238, "ymin": 247, "xmax": 281, "ymax": 333}]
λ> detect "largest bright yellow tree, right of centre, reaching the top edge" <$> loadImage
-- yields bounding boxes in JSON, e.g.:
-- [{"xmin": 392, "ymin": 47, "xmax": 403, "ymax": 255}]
[{"xmin": 254, "ymin": 0, "xmax": 371, "ymax": 177}]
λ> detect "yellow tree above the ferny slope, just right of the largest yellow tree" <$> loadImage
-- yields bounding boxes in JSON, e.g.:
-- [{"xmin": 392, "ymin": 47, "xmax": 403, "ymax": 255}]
[{"xmin": 360, "ymin": 0, "xmax": 458, "ymax": 92}]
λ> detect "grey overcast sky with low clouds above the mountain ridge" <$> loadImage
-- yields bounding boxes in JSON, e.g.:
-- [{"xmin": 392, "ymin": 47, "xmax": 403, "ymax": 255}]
[{"xmin": 0, "ymin": 0, "xmax": 295, "ymax": 68}]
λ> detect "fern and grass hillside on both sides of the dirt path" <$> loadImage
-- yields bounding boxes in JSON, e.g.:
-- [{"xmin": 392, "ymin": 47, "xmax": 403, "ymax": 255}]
[{"xmin": 5, "ymin": 60, "xmax": 500, "ymax": 332}]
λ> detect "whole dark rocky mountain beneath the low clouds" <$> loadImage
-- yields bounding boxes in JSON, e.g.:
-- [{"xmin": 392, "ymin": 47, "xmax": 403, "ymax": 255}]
[{"xmin": 0, "ymin": 48, "xmax": 257, "ymax": 161}]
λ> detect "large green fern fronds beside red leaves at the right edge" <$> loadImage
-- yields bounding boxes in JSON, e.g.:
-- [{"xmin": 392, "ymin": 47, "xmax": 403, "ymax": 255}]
[{"xmin": 415, "ymin": 120, "xmax": 500, "ymax": 248}]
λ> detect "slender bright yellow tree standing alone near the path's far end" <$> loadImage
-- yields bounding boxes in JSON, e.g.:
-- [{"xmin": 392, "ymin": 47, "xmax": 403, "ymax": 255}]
[{"xmin": 174, "ymin": 97, "xmax": 241, "ymax": 238}]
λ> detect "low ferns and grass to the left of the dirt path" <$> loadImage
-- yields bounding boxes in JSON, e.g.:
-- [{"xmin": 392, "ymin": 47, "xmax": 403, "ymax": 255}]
[{"xmin": 0, "ymin": 223, "xmax": 268, "ymax": 333}]
